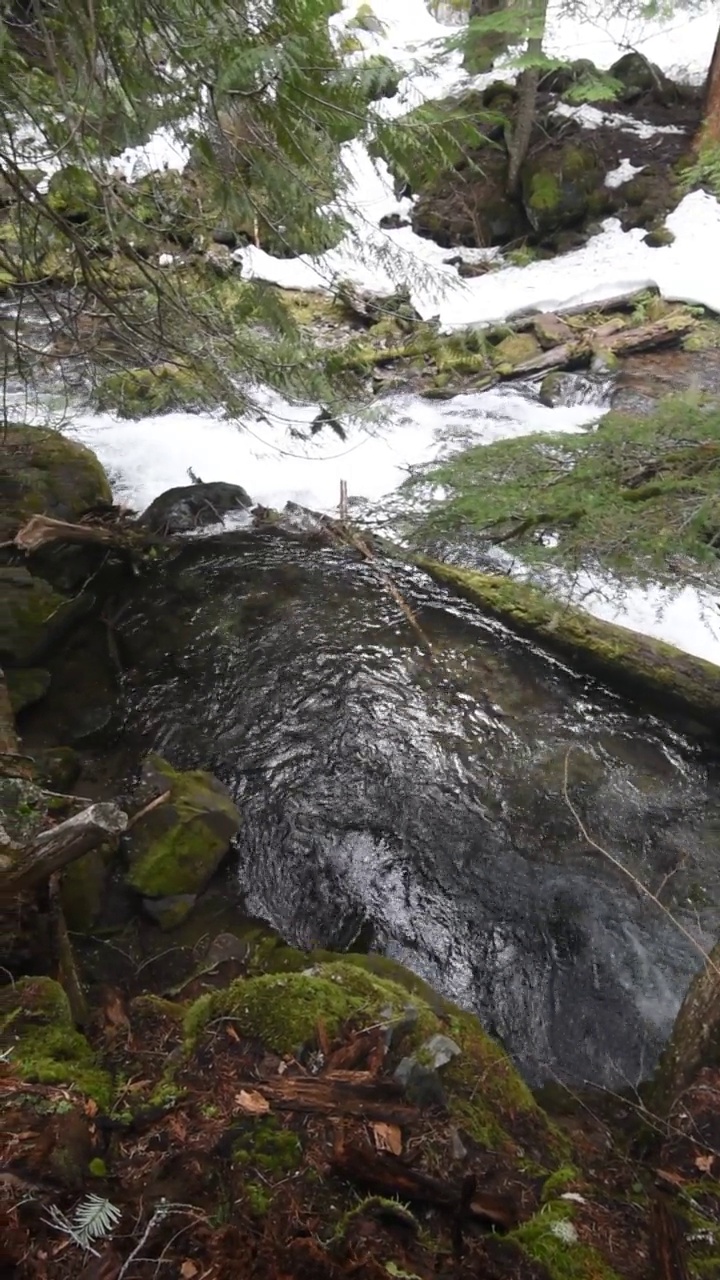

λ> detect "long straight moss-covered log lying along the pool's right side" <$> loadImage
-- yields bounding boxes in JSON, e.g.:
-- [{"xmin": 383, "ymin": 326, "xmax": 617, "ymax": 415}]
[{"xmin": 419, "ymin": 557, "xmax": 720, "ymax": 730}]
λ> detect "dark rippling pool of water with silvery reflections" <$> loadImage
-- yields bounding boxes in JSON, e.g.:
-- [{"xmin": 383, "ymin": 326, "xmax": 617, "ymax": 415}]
[{"xmin": 114, "ymin": 532, "xmax": 720, "ymax": 1084}]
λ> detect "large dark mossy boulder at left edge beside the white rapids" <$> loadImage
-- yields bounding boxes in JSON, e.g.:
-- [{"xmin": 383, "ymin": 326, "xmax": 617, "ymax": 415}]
[{"xmin": 0, "ymin": 425, "xmax": 113, "ymax": 540}]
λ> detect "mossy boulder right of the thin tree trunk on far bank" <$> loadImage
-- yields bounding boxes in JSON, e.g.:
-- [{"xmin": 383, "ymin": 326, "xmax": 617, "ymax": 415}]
[{"xmin": 520, "ymin": 140, "xmax": 612, "ymax": 237}]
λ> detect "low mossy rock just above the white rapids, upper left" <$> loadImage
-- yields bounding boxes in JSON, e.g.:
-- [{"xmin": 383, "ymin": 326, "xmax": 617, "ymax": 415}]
[{"xmin": 95, "ymin": 364, "xmax": 217, "ymax": 417}]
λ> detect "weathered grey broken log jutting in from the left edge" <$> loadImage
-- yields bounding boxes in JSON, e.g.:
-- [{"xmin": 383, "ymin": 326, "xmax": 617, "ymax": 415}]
[{"xmin": 0, "ymin": 803, "xmax": 128, "ymax": 897}]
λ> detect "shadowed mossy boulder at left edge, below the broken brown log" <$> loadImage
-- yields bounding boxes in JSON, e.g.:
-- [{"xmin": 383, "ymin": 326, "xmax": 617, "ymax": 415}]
[{"xmin": 0, "ymin": 564, "xmax": 86, "ymax": 667}]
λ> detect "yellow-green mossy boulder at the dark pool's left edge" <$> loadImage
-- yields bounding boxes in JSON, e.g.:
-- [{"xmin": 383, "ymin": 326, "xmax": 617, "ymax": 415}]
[{"xmin": 127, "ymin": 755, "xmax": 241, "ymax": 924}]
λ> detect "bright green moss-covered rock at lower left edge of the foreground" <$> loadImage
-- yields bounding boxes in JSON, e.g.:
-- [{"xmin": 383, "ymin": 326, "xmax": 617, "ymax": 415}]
[{"xmin": 0, "ymin": 978, "xmax": 113, "ymax": 1108}]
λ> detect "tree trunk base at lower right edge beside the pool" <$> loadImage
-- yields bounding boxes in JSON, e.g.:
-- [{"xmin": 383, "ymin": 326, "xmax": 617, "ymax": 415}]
[{"xmin": 651, "ymin": 942, "xmax": 720, "ymax": 1114}]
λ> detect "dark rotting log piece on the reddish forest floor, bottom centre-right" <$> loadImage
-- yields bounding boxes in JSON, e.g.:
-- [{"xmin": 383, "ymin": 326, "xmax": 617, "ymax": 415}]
[{"xmin": 332, "ymin": 1143, "xmax": 518, "ymax": 1231}]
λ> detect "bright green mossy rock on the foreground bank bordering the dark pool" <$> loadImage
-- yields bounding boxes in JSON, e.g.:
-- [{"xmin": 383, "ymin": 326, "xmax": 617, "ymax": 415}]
[{"xmin": 184, "ymin": 956, "xmax": 556, "ymax": 1167}]
